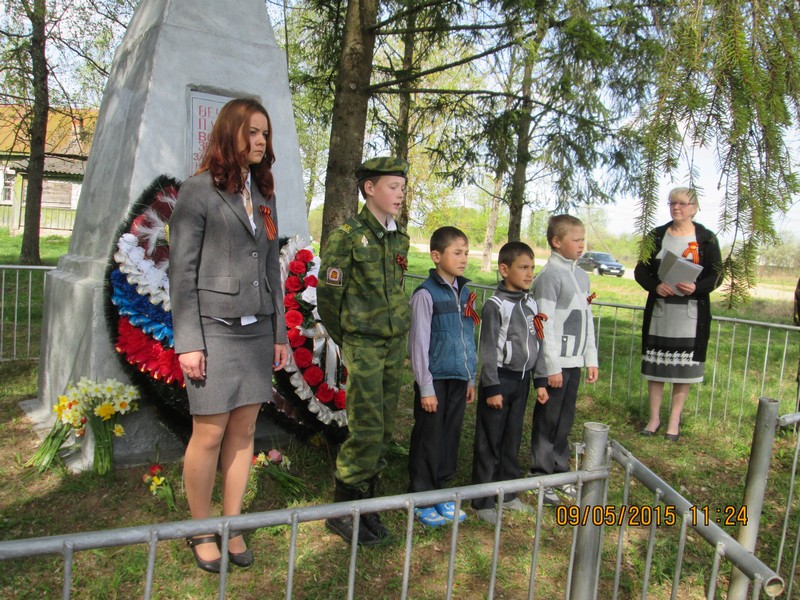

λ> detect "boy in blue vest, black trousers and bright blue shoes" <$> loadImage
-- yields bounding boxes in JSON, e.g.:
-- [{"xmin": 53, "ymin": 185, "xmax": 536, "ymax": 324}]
[{"xmin": 408, "ymin": 227, "xmax": 480, "ymax": 527}]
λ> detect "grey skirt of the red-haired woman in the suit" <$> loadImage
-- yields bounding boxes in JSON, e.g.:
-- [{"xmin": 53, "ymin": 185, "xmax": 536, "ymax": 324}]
[{"xmin": 186, "ymin": 317, "xmax": 275, "ymax": 415}]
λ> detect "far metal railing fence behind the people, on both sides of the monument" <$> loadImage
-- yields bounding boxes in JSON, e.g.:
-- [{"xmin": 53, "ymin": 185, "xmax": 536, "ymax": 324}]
[{"xmin": 0, "ymin": 266, "xmax": 800, "ymax": 429}]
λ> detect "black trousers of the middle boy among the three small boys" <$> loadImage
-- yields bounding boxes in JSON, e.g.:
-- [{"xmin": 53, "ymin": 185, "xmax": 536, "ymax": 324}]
[{"xmin": 472, "ymin": 371, "xmax": 531, "ymax": 510}]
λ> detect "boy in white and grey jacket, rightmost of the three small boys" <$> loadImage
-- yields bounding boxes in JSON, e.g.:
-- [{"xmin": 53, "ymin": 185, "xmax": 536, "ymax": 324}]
[{"xmin": 531, "ymin": 215, "xmax": 598, "ymax": 504}]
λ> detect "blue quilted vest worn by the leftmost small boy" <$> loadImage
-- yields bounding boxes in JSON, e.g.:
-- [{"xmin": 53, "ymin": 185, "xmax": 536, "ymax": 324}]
[{"xmin": 417, "ymin": 269, "xmax": 478, "ymax": 380}]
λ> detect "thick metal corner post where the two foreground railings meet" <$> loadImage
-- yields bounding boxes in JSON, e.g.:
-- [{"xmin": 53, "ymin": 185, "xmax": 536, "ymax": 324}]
[{"xmin": 569, "ymin": 423, "xmax": 611, "ymax": 600}]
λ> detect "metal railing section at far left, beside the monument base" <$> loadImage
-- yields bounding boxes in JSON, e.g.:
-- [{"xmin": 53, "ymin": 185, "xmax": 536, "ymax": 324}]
[{"xmin": 0, "ymin": 265, "xmax": 55, "ymax": 361}]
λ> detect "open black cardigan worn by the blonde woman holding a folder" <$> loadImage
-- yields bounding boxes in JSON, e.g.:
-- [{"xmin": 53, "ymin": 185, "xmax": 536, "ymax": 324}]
[{"xmin": 633, "ymin": 221, "xmax": 722, "ymax": 362}]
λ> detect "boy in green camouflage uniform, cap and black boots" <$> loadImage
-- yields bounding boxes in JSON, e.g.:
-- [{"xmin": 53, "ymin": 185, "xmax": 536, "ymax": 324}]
[{"xmin": 317, "ymin": 157, "xmax": 411, "ymax": 545}]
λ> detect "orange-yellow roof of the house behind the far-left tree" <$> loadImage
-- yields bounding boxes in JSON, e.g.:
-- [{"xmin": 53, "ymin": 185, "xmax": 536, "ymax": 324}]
[{"xmin": 0, "ymin": 104, "xmax": 97, "ymax": 158}]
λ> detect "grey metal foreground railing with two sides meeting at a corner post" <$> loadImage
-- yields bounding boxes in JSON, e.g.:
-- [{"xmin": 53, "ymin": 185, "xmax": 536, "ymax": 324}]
[{"xmin": 0, "ymin": 423, "xmax": 784, "ymax": 600}]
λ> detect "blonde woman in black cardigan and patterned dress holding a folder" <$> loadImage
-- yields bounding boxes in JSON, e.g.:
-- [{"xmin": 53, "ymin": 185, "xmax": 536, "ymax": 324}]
[{"xmin": 634, "ymin": 188, "xmax": 722, "ymax": 442}]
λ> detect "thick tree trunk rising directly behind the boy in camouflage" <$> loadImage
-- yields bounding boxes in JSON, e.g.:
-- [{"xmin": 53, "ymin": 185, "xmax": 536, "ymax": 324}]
[{"xmin": 320, "ymin": 0, "xmax": 378, "ymax": 247}]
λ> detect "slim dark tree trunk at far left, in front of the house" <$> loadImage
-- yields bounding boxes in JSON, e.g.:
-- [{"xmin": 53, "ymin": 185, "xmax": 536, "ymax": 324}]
[{"xmin": 19, "ymin": 0, "xmax": 50, "ymax": 265}]
